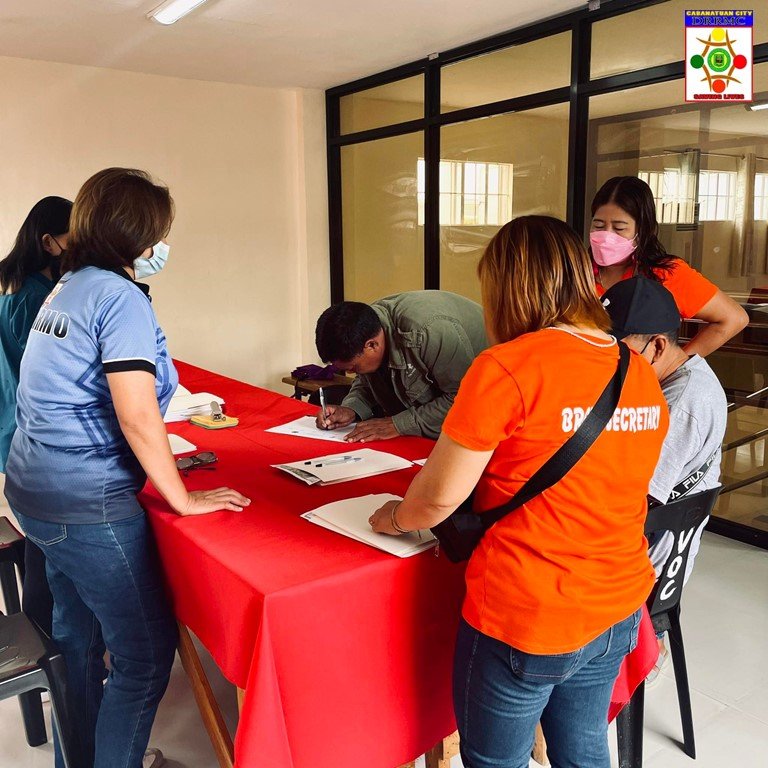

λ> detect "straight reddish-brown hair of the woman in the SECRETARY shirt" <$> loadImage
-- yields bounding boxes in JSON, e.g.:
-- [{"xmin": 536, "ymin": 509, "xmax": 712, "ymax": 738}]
[{"xmin": 478, "ymin": 216, "xmax": 611, "ymax": 343}]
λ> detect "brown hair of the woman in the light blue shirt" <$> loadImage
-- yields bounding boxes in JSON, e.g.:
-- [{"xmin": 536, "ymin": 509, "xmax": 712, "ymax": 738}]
[{"xmin": 62, "ymin": 168, "xmax": 173, "ymax": 271}]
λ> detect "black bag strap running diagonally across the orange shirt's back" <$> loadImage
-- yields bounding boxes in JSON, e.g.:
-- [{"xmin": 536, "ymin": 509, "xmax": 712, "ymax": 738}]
[{"xmin": 480, "ymin": 341, "xmax": 630, "ymax": 530}]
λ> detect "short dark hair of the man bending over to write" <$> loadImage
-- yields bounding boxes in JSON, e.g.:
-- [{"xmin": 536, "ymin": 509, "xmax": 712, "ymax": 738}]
[{"xmin": 315, "ymin": 301, "xmax": 382, "ymax": 363}]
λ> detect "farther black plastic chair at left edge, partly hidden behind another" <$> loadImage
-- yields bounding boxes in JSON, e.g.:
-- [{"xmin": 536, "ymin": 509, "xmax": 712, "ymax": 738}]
[{"xmin": 0, "ymin": 517, "xmax": 48, "ymax": 747}]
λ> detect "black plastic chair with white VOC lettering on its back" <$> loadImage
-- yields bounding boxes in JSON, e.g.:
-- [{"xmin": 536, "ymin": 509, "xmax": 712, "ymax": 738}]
[{"xmin": 616, "ymin": 486, "xmax": 720, "ymax": 768}]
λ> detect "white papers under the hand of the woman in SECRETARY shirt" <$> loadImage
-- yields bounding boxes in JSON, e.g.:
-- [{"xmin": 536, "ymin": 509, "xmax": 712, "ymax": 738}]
[{"xmin": 302, "ymin": 493, "xmax": 437, "ymax": 557}]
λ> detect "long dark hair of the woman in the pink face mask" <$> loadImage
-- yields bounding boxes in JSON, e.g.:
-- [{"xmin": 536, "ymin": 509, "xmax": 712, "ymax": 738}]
[{"xmin": 592, "ymin": 176, "xmax": 675, "ymax": 281}]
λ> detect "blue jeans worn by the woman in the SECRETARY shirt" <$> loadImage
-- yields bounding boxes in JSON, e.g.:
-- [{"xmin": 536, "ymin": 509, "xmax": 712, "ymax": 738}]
[{"xmin": 453, "ymin": 611, "xmax": 640, "ymax": 768}]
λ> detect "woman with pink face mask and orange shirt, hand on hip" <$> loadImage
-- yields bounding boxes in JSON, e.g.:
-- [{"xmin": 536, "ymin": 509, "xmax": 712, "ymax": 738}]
[{"xmin": 589, "ymin": 176, "xmax": 749, "ymax": 357}]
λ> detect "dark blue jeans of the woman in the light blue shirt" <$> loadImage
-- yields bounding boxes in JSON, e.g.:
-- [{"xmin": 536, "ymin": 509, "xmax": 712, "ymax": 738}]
[{"xmin": 16, "ymin": 512, "xmax": 177, "ymax": 768}]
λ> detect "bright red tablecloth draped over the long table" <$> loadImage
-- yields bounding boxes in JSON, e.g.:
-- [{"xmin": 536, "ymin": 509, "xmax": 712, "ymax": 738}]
[{"xmin": 141, "ymin": 363, "xmax": 656, "ymax": 768}]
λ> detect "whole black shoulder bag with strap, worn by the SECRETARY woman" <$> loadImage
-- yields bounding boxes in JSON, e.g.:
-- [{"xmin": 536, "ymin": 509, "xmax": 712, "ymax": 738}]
[{"xmin": 432, "ymin": 342, "xmax": 629, "ymax": 563}]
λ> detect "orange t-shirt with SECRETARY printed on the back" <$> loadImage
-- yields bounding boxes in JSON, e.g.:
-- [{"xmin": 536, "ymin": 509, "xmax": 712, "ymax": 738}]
[{"xmin": 443, "ymin": 329, "xmax": 669, "ymax": 654}]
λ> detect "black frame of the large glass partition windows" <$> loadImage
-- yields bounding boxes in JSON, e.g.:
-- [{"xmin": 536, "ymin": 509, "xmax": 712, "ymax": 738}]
[{"xmin": 325, "ymin": 0, "xmax": 768, "ymax": 549}]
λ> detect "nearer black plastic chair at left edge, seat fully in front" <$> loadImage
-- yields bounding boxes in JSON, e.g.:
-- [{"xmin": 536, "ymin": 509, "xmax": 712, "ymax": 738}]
[{"xmin": 0, "ymin": 613, "xmax": 81, "ymax": 768}]
